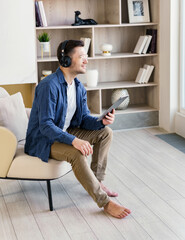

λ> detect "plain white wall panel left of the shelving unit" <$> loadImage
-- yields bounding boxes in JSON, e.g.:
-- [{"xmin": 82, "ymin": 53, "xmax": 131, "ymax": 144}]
[{"xmin": 0, "ymin": 0, "xmax": 37, "ymax": 85}]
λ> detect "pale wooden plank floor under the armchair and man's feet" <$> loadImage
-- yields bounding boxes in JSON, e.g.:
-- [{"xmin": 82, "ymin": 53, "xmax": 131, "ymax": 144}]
[{"xmin": 0, "ymin": 128, "xmax": 185, "ymax": 240}]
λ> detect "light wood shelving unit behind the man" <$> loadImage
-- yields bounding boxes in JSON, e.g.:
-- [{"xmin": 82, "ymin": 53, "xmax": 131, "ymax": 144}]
[{"xmin": 36, "ymin": 0, "xmax": 159, "ymax": 128}]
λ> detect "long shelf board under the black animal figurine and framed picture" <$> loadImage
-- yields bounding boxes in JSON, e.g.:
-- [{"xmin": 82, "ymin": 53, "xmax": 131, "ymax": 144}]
[{"xmin": 36, "ymin": 22, "xmax": 158, "ymax": 31}]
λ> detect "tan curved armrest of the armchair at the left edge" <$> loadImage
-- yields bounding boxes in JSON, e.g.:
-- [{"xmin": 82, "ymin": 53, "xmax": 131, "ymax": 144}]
[{"xmin": 0, "ymin": 127, "xmax": 17, "ymax": 178}]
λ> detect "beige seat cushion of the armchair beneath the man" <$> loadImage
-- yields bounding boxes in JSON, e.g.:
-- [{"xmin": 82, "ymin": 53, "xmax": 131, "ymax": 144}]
[{"xmin": 7, "ymin": 142, "xmax": 71, "ymax": 180}]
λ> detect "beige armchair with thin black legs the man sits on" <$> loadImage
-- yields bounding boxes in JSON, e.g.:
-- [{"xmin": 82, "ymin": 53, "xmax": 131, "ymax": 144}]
[{"xmin": 0, "ymin": 88, "xmax": 71, "ymax": 211}]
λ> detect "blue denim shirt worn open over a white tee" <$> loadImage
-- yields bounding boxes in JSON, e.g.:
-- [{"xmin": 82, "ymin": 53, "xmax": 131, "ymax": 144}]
[{"xmin": 25, "ymin": 68, "xmax": 104, "ymax": 162}]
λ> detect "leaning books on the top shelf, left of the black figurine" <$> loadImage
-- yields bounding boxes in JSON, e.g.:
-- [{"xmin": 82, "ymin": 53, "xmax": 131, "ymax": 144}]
[{"xmin": 35, "ymin": 1, "xmax": 48, "ymax": 27}]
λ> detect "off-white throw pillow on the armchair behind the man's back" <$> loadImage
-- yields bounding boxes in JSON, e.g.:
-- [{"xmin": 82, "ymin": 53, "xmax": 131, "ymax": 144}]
[{"xmin": 0, "ymin": 92, "xmax": 28, "ymax": 141}]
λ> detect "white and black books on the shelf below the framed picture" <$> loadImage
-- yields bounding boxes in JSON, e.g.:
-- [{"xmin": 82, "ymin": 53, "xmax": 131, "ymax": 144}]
[{"xmin": 133, "ymin": 29, "xmax": 157, "ymax": 54}]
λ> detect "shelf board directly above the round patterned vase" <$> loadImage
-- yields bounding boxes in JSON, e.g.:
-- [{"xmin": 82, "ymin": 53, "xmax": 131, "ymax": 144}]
[{"xmin": 85, "ymin": 81, "xmax": 158, "ymax": 91}]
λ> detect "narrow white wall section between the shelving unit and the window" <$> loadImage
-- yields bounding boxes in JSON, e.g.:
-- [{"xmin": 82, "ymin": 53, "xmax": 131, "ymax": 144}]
[{"xmin": 159, "ymin": 0, "xmax": 180, "ymax": 132}]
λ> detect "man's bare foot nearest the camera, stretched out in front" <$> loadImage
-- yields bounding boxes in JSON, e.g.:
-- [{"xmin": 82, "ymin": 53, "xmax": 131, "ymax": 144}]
[{"xmin": 104, "ymin": 201, "xmax": 131, "ymax": 219}]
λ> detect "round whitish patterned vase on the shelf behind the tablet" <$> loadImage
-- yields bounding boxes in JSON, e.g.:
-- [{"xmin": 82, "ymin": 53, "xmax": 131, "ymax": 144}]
[{"xmin": 111, "ymin": 88, "xmax": 130, "ymax": 110}]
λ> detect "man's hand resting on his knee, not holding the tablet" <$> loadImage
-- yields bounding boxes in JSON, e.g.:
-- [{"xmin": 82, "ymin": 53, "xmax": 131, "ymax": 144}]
[{"xmin": 72, "ymin": 138, "xmax": 93, "ymax": 156}]
